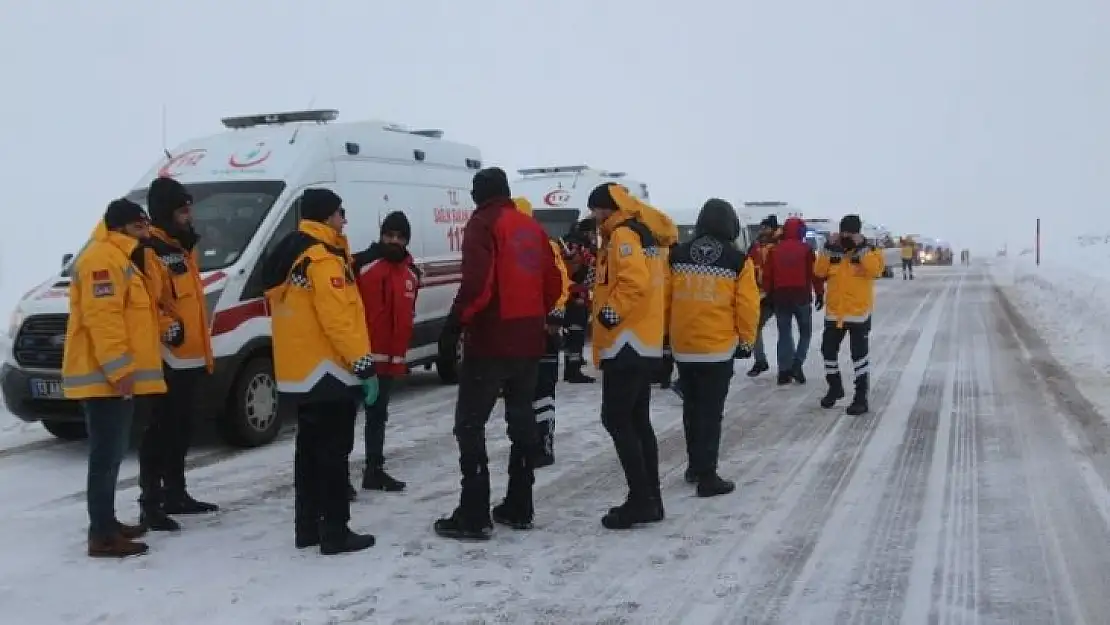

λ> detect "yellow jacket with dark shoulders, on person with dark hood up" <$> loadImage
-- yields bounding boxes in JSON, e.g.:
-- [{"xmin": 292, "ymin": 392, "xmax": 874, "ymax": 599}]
[{"xmin": 668, "ymin": 236, "xmax": 759, "ymax": 362}]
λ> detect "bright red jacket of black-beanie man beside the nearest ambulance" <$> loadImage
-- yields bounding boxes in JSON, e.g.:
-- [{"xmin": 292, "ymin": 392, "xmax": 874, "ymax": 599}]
[{"xmin": 357, "ymin": 243, "xmax": 420, "ymax": 376}]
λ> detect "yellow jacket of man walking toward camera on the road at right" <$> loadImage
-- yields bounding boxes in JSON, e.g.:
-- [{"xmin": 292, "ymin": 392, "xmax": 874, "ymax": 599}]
[{"xmin": 814, "ymin": 245, "xmax": 886, "ymax": 327}]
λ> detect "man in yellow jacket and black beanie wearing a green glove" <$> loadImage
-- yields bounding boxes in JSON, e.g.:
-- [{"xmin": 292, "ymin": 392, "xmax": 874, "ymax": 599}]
[{"xmin": 262, "ymin": 189, "xmax": 377, "ymax": 555}]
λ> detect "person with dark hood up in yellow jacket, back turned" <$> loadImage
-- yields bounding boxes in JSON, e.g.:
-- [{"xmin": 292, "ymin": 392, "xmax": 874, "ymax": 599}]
[{"xmin": 668, "ymin": 198, "xmax": 759, "ymax": 497}]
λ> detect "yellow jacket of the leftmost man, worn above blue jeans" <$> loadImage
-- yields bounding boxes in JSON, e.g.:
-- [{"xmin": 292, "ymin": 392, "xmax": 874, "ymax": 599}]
[{"xmin": 62, "ymin": 222, "xmax": 165, "ymax": 400}]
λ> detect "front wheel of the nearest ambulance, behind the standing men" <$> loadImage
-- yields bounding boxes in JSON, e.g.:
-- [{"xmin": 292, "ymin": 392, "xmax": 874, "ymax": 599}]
[{"xmin": 221, "ymin": 356, "xmax": 281, "ymax": 447}]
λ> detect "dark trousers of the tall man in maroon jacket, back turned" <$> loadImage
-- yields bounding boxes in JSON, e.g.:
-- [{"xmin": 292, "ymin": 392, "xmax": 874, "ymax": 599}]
[{"xmin": 454, "ymin": 355, "xmax": 539, "ymax": 526}]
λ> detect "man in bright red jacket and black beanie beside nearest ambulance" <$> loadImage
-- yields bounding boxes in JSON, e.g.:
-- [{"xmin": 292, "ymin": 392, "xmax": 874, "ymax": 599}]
[{"xmin": 354, "ymin": 211, "xmax": 420, "ymax": 493}]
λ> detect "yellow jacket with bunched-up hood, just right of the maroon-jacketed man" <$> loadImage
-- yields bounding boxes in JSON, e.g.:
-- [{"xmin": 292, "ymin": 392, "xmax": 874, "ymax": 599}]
[{"xmin": 592, "ymin": 184, "xmax": 678, "ymax": 366}]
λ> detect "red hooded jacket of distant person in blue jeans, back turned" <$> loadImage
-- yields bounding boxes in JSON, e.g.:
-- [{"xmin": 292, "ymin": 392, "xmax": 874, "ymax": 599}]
[{"xmin": 763, "ymin": 218, "xmax": 825, "ymax": 306}]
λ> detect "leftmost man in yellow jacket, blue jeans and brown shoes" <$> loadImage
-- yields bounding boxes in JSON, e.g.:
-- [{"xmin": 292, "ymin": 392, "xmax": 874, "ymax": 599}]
[{"xmin": 62, "ymin": 199, "xmax": 165, "ymax": 557}]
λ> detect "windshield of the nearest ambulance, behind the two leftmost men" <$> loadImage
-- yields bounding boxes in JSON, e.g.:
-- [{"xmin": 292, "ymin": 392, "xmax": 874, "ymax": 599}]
[{"xmin": 128, "ymin": 180, "xmax": 285, "ymax": 271}]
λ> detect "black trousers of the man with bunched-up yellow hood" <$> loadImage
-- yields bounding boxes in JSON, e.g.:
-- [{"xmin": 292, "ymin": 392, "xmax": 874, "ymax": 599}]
[{"xmin": 602, "ymin": 359, "xmax": 661, "ymax": 502}]
